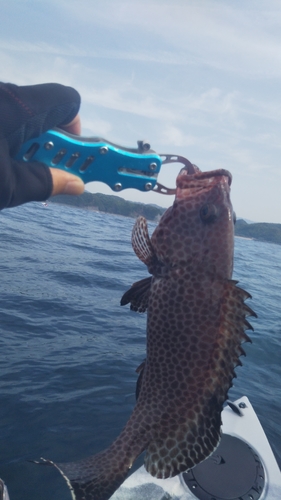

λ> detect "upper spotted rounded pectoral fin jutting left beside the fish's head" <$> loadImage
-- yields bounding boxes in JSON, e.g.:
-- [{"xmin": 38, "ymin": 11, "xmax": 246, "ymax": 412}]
[{"xmin": 132, "ymin": 216, "xmax": 156, "ymax": 266}]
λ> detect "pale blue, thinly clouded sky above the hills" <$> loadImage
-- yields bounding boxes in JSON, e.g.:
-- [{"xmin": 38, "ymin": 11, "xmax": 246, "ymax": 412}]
[{"xmin": 0, "ymin": 0, "xmax": 281, "ymax": 223}]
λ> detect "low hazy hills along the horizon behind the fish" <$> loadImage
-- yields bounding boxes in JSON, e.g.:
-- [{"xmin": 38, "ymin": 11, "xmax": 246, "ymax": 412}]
[{"xmin": 49, "ymin": 191, "xmax": 281, "ymax": 245}]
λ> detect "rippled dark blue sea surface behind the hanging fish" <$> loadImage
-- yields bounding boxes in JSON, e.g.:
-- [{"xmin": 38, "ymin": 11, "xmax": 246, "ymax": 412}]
[{"xmin": 0, "ymin": 203, "xmax": 281, "ymax": 500}]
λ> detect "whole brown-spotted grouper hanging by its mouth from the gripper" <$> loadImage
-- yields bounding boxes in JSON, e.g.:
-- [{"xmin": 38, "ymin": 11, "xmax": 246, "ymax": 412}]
[{"xmin": 42, "ymin": 165, "xmax": 256, "ymax": 500}]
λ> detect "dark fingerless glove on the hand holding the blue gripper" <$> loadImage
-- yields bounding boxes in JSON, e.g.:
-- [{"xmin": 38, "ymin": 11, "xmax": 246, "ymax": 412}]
[{"xmin": 0, "ymin": 83, "xmax": 80, "ymax": 209}]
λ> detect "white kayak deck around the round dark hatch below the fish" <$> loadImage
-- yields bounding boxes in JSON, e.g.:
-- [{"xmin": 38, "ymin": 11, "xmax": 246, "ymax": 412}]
[{"xmin": 111, "ymin": 396, "xmax": 281, "ymax": 500}]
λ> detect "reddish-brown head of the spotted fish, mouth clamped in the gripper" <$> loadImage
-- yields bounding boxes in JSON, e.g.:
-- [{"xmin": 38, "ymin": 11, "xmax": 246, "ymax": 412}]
[{"xmin": 151, "ymin": 166, "xmax": 235, "ymax": 278}]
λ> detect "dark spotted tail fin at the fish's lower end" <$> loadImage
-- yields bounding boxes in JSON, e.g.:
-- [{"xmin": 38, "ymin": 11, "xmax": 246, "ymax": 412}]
[{"xmin": 44, "ymin": 447, "xmax": 131, "ymax": 500}]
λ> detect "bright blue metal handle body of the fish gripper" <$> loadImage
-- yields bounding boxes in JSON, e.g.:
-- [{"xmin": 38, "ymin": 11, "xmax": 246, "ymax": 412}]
[{"xmin": 15, "ymin": 129, "xmax": 162, "ymax": 191}]
